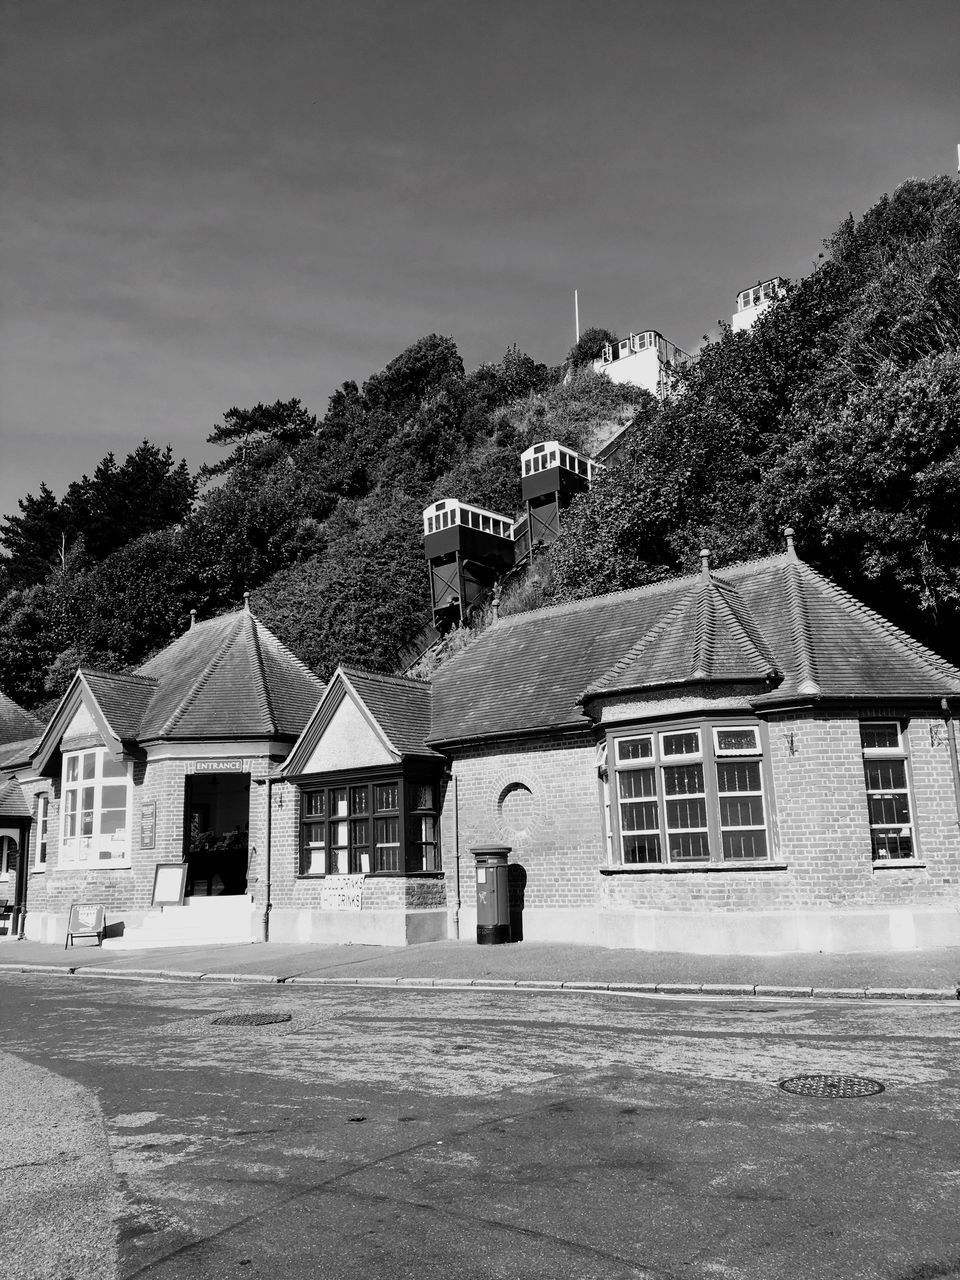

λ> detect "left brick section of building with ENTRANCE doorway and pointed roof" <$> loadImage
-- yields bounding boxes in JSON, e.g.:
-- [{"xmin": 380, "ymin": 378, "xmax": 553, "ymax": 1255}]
[{"xmin": 0, "ymin": 609, "xmax": 323, "ymax": 946}]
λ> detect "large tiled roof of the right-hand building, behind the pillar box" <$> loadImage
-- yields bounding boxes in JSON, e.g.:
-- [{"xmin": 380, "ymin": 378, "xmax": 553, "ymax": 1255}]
[{"xmin": 430, "ymin": 553, "xmax": 960, "ymax": 744}]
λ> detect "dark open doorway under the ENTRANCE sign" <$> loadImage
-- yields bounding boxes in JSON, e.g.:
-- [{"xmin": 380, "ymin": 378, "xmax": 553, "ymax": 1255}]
[{"xmin": 184, "ymin": 773, "xmax": 250, "ymax": 897}]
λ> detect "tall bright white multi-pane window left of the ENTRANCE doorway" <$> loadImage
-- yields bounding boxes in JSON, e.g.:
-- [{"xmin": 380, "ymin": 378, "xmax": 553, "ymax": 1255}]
[{"xmin": 60, "ymin": 746, "xmax": 131, "ymax": 867}]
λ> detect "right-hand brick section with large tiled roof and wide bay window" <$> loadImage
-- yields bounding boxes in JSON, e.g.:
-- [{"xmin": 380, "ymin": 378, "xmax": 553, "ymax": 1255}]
[{"xmin": 429, "ymin": 540, "xmax": 960, "ymax": 952}]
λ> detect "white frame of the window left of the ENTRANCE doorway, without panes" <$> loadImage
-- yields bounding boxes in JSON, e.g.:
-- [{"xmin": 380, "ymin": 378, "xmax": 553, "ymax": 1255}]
[{"xmin": 59, "ymin": 746, "xmax": 133, "ymax": 870}]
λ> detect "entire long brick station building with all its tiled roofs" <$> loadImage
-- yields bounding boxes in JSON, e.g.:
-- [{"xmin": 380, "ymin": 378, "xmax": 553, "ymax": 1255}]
[{"xmin": 0, "ymin": 543, "xmax": 960, "ymax": 952}]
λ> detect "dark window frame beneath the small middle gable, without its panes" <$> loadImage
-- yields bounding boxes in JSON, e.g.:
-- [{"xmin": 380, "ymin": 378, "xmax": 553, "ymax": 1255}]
[{"xmin": 291, "ymin": 765, "xmax": 443, "ymax": 879}]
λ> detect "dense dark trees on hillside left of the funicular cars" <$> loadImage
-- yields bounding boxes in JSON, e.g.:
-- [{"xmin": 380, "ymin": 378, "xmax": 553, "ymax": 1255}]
[{"xmin": 0, "ymin": 334, "xmax": 641, "ymax": 708}]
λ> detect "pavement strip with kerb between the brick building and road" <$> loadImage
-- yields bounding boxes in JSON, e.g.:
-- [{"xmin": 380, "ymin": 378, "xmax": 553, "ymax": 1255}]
[{"xmin": 0, "ymin": 940, "xmax": 960, "ymax": 1001}]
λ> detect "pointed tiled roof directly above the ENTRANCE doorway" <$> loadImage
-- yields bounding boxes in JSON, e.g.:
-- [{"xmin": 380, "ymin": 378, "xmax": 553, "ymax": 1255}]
[{"xmin": 137, "ymin": 609, "xmax": 324, "ymax": 741}]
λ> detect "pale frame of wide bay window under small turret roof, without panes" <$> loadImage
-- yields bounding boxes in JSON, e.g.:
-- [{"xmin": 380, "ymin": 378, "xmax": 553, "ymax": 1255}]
[{"xmin": 607, "ymin": 716, "xmax": 777, "ymax": 870}]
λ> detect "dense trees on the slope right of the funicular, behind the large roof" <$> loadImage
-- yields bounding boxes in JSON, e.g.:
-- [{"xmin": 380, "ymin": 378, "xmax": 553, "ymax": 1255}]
[{"xmin": 550, "ymin": 178, "xmax": 960, "ymax": 660}]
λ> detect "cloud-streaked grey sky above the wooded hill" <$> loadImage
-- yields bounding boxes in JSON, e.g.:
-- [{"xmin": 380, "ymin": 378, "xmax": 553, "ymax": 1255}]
[{"xmin": 0, "ymin": 0, "xmax": 960, "ymax": 515}]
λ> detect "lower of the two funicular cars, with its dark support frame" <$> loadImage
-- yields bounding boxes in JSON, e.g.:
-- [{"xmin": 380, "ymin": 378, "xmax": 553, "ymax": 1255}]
[{"xmin": 424, "ymin": 498, "xmax": 516, "ymax": 631}]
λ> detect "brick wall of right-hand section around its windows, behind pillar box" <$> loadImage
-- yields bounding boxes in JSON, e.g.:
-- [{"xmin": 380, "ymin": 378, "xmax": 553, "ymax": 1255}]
[{"xmin": 444, "ymin": 713, "xmax": 960, "ymax": 913}]
